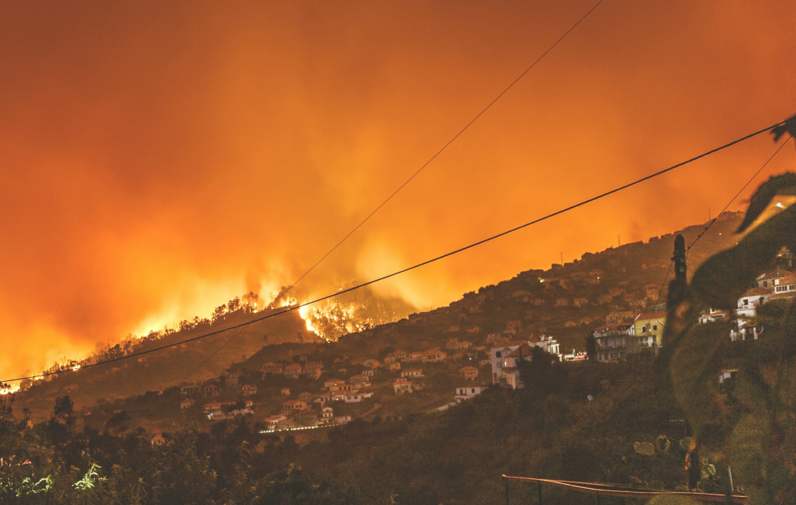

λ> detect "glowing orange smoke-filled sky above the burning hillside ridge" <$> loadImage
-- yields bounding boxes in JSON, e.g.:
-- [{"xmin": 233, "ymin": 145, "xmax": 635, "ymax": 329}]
[{"xmin": 0, "ymin": 0, "xmax": 796, "ymax": 376}]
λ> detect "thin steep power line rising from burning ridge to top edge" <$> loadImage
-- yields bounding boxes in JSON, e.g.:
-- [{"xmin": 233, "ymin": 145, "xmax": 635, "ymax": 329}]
[{"xmin": 288, "ymin": 0, "xmax": 603, "ymax": 290}]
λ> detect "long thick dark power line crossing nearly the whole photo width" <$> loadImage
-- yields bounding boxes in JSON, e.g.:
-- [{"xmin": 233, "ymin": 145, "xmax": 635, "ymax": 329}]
[{"xmin": 0, "ymin": 116, "xmax": 784, "ymax": 383}]
